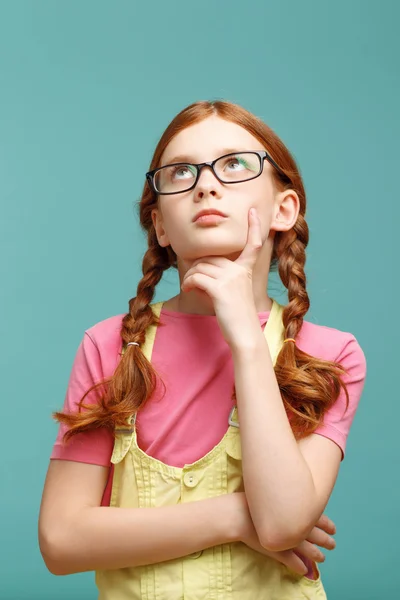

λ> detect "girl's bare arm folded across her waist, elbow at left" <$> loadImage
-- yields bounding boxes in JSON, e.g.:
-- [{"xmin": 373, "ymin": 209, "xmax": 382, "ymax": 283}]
[{"xmin": 39, "ymin": 460, "xmax": 239, "ymax": 575}]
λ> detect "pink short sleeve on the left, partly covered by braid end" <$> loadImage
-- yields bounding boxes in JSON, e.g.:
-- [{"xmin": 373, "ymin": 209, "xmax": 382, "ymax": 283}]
[{"xmin": 50, "ymin": 332, "xmax": 113, "ymax": 467}]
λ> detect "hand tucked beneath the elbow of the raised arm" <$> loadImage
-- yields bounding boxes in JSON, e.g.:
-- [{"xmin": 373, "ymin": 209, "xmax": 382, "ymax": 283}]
[{"xmin": 232, "ymin": 492, "xmax": 336, "ymax": 575}]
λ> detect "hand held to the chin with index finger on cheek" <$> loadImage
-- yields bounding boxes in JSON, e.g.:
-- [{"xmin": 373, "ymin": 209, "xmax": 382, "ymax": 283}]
[{"xmin": 181, "ymin": 209, "xmax": 262, "ymax": 345}]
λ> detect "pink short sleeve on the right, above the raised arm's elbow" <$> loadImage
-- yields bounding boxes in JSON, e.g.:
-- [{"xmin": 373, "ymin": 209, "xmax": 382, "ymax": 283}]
[{"xmin": 314, "ymin": 334, "xmax": 367, "ymax": 460}]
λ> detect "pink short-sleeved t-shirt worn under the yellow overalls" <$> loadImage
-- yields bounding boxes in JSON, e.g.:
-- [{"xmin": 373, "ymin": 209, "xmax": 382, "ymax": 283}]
[{"xmin": 51, "ymin": 309, "xmax": 366, "ymax": 506}]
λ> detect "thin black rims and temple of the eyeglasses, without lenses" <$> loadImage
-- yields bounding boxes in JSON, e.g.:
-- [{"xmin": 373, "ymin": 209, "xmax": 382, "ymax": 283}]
[{"xmin": 146, "ymin": 150, "xmax": 290, "ymax": 196}]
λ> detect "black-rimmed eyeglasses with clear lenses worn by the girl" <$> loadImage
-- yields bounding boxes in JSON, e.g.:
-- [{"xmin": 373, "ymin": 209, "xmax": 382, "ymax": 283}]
[{"xmin": 146, "ymin": 150, "xmax": 290, "ymax": 194}]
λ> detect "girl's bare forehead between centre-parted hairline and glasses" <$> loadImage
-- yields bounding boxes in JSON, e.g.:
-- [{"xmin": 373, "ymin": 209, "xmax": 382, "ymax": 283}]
[{"xmin": 161, "ymin": 116, "xmax": 264, "ymax": 165}]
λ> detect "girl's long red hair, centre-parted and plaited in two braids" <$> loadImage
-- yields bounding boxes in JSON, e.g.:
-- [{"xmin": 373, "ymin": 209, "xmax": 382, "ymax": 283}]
[{"xmin": 53, "ymin": 100, "xmax": 349, "ymax": 441}]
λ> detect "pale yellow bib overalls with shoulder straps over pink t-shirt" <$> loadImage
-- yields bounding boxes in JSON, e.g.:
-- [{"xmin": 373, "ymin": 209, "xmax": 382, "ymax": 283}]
[{"xmin": 96, "ymin": 300, "xmax": 326, "ymax": 600}]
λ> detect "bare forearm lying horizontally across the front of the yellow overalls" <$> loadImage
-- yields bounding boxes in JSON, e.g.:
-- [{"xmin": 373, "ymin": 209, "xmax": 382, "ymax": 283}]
[{"xmin": 42, "ymin": 495, "xmax": 236, "ymax": 575}]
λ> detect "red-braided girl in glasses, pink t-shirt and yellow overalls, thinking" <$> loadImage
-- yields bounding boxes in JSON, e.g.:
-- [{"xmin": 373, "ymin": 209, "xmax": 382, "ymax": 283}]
[{"xmin": 39, "ymin": 101, "xmax": 366, "ymax": 600}]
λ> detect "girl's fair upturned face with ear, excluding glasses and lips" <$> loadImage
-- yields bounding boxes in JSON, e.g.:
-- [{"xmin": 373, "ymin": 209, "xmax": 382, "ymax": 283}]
[{"xmin": 152, "ymin": 116, "xmax": 297, "ymax": 263}]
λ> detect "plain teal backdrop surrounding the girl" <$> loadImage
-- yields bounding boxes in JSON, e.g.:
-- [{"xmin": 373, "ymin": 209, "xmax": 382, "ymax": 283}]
[{"xmin": 0, "ymin": 0, "xmax": 400, "ymax": 600}]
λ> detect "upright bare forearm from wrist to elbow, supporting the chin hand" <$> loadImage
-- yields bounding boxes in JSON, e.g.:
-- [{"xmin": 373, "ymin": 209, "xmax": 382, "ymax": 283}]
[{"xmin": 232, "ymin": 331, "xmax": 316, "ymax": 548}]
